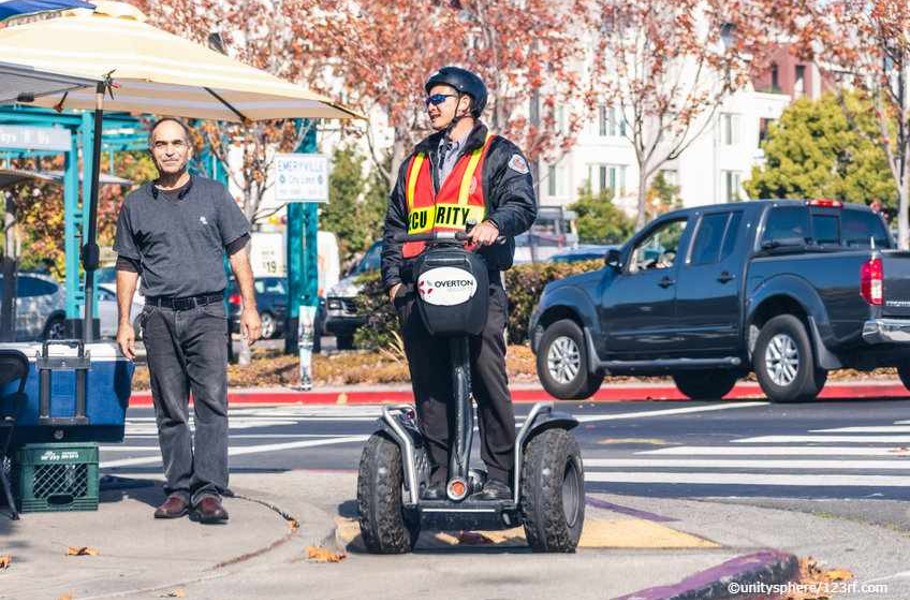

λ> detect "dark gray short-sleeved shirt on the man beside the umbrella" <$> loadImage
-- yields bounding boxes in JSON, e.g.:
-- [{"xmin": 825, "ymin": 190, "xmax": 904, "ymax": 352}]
[{"xmin": 114, "ymin": 175, "xmax": 250, "ymax": 298}]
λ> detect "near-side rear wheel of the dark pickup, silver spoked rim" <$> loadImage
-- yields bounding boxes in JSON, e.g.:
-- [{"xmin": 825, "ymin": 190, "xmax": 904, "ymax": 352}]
[{"xmin": 752, "ymin": 315, "xmax": 828, "ymax": 402}]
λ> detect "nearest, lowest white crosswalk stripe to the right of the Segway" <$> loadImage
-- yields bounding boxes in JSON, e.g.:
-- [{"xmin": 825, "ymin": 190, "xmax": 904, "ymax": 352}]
[{"xmin": 585, "ymin": 471, "xmax": 910, "ymax": 488}]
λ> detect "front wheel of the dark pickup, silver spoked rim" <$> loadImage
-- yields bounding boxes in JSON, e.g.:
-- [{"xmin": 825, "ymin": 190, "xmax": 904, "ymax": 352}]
[{"xmin": 537, "ymin": 319, "xmax": 603, "ymax": 400}]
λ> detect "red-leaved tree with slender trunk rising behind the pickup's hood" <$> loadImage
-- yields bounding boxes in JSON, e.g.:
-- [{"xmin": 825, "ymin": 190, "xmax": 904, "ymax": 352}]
[{"xmin": 586, "ymin": 0, "xmax": 774, "ymax": 227}]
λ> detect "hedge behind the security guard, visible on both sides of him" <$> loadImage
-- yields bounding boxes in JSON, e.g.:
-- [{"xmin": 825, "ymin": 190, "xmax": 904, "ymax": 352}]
[{"xmin": 354, "ymin": 260, "xmax": 603, "ymax": 350}]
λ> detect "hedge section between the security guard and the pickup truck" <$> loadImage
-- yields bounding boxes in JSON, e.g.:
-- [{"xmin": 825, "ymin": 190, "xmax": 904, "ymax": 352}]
[{"xmin": 506, "ymin": 260, "xmax": 604, "ymax": 344}]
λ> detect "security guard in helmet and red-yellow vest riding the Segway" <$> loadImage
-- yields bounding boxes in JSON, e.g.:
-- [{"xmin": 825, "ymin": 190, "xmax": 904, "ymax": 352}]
[{"xmin": 382, "ymin": 67, "xmax": 537, "ymax": 500}]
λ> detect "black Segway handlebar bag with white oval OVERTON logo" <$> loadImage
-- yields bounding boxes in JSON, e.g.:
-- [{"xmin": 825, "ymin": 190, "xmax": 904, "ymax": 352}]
[{"xmin": 414, "ymin": 246, "xmax": 490, "ymax": 336}]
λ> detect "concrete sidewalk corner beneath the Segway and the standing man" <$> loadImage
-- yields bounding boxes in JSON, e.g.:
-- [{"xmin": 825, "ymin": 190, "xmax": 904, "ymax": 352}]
[{"xmin": 0, "ymin": 471, "xmax": 908, "ymax": 600}]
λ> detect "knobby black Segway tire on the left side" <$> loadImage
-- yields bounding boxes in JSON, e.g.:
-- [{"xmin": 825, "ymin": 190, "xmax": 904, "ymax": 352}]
[{"xmin": 357, "ymin": 433, "xmax": 420, "ymax": 554}]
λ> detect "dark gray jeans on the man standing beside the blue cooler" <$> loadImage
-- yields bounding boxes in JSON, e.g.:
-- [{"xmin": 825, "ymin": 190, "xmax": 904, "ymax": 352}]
[{"xmin": 142, "ymin": 302, "xmax": 228, "ymax": 504}]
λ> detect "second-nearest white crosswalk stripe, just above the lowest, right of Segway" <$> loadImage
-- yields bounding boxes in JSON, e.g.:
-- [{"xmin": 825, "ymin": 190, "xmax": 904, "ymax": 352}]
[{"xmin": 584, "ymin": 458, "xmax": 910, "ymax": 471}]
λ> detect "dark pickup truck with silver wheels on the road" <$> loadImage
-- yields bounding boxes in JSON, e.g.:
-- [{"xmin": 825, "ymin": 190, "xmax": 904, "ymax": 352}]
[{"xmin": 529, "ymin": 200, "xmax": 910, "ymax": 402}]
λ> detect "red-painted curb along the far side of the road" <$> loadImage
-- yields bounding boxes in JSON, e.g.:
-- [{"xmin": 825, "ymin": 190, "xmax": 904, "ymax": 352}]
[{"xmin": 130, "ymin": 383, "xmax": 910, "ymax": 407}]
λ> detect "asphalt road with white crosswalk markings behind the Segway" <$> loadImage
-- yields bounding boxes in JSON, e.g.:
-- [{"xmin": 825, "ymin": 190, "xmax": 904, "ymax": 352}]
[{"xmin": 101, "ymin": 399, "xmax": 910, "ymax": 530}]
